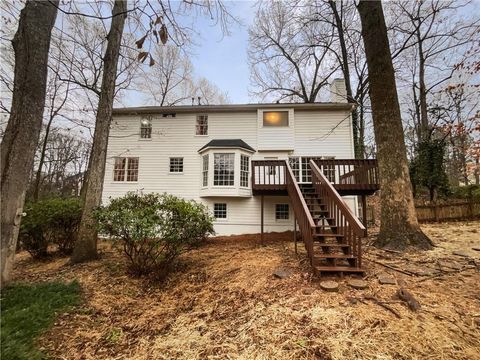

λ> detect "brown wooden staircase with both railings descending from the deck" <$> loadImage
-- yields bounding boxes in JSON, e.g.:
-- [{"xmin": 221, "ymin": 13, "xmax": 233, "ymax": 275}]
[{"xmin": 286, "ymin": 160, "xmax": 366, "ymax": 276}]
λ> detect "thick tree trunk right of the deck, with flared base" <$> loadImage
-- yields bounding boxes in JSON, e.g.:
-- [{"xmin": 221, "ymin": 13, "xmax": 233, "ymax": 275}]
[{"xmin": 358, "ymin": 0, "xmax": 432, "ymax": 249}]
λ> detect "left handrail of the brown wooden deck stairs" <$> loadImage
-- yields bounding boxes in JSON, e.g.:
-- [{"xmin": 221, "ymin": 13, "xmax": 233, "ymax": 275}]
[{"xmin": 285, "ymin": 160, "xmax": 315, "ymax": 264}]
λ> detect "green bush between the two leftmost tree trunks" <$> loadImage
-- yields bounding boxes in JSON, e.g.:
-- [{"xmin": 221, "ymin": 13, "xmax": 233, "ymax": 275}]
[{"xmin": 19, "ymin": 198, "xmax": 82, "ymax": 258}]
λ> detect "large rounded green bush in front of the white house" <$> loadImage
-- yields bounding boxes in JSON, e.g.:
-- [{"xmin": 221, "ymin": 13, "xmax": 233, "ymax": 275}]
[{"xmin": 94, "ymin": 192, "xmax": 214, "ymax": 277}]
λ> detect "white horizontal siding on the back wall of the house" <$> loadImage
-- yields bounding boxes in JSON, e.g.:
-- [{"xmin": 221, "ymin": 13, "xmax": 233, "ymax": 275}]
[{"xmin": 102, "ymin": 110, "xmax": 355, "ymax": 235}]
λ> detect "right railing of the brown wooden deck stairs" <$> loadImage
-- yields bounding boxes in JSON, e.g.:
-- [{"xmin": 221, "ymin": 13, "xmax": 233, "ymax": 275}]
[{"xmin": 310, "ymin": 160, "xmax": 367, "ymax": 268}]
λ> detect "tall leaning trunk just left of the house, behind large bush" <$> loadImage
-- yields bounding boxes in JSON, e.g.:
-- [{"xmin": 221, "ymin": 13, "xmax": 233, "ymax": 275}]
[{"xmin": 71, "ymin": 0, "xmax": 127, "ymax": 263}]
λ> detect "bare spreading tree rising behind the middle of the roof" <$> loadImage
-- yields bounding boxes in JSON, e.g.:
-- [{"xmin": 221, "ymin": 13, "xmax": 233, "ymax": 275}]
[{"xmin": 248, "ymin": 1, "xmax": 340, "ymax": 103}]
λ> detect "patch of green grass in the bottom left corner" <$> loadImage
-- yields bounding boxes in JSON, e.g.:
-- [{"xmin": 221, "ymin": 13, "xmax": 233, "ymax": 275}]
[{"xmin": 0, "ymin": 282, "xmax": 80, "ymax": 360}]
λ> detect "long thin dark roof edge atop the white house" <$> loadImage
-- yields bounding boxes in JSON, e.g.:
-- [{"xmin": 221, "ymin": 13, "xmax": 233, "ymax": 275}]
[{"xmin": 113, "ymin": 102, "xmax": 355, "ymax": 115}]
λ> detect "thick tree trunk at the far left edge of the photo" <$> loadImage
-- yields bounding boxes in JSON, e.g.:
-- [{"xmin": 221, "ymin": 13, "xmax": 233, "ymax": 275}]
[{"xmin": 0, "ymin": 0, "xmax": 58, "ymax": 286}]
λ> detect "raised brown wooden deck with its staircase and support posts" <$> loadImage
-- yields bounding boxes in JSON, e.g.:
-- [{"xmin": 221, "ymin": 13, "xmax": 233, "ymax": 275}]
[{"xmin": 252, "ymin": 159, "xmax": 379, "ymax": 275}]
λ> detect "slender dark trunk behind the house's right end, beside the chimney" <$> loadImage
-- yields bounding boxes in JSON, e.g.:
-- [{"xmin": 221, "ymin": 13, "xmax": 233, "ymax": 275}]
[{"xmin": 328, "ymin": 0, "xmax": 364, "ymax": 159}]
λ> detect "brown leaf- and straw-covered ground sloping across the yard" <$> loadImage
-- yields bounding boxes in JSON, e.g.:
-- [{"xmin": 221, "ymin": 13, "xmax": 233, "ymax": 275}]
[{"xmin": 9, "ymin": 221, "xmax": 480, "ymax": 359}]
